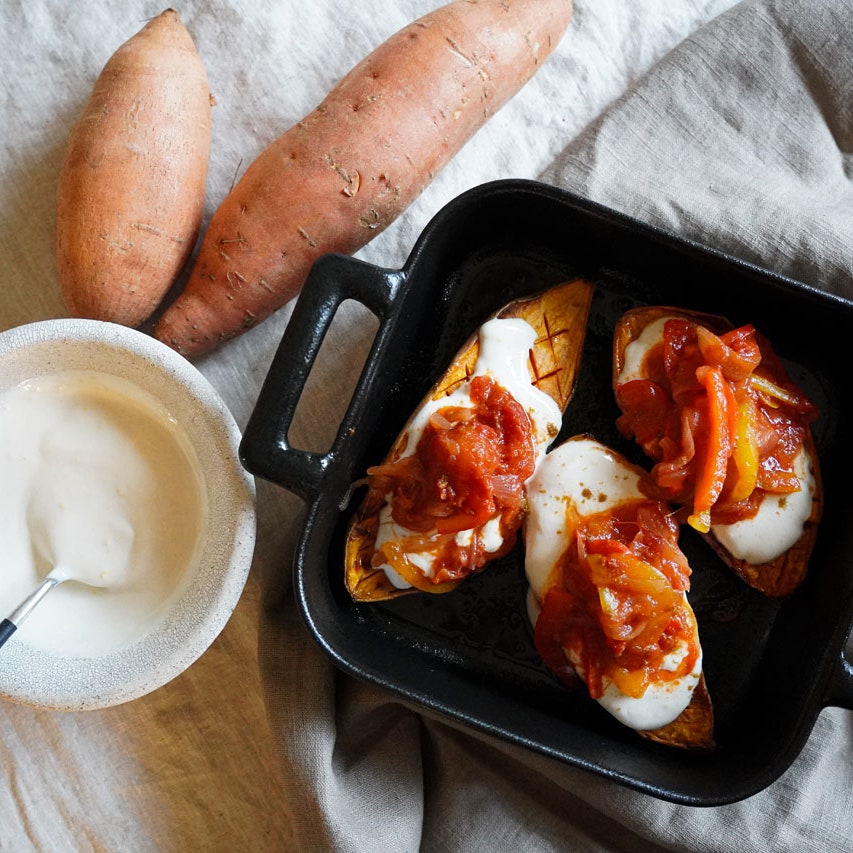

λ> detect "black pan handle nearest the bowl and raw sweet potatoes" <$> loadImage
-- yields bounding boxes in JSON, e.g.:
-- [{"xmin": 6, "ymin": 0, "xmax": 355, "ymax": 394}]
[{"xmin": 240, "ymin": 253, "xmax": 403, "ymax": 501}]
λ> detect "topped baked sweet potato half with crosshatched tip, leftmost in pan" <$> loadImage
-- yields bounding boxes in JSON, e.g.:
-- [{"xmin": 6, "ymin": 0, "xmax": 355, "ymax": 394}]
[{"xmin": 345, "ymin": 279, "xmax": 593, "ymax": 601}]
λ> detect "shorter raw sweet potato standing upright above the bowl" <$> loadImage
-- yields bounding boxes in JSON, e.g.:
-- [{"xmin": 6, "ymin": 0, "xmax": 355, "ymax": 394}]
[{"xmin": 56, "ymin": 9, "xmax": 211, "ymax": 326}]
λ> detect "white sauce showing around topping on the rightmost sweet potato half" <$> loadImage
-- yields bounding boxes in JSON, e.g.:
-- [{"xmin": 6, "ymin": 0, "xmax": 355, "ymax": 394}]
[{"xmin": 618, "ymin": 317, "xmax": 816, "ymax": 565}]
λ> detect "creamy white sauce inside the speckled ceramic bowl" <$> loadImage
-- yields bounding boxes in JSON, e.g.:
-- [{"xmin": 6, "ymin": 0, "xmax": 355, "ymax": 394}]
[{"xmin": 0, "ymin": 371, "xmax": 207, "ymax": 657}]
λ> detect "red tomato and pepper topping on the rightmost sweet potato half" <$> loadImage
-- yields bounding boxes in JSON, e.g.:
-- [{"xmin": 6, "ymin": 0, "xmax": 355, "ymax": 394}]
[{"xmin": 616, "ymin": 318, "xmax": 818, "ymax": 532}]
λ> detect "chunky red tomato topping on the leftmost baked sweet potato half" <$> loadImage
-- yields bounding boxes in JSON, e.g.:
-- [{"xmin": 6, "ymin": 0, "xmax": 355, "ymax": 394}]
[{"xmin": 368, "ymin": 376, "xmax": 535, "ymax": 584}]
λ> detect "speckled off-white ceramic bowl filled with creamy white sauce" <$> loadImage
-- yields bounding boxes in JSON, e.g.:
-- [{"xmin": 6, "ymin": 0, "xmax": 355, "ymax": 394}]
[{"xmin": 0, "ymin": 319, "xmax": 256, "ymax": 711}]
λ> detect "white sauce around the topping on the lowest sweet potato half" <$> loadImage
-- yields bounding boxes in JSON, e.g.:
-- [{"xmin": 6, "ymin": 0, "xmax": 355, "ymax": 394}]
[{"xmin": 524, "ymin": 439, "xmax": 702, "ymax": 730}]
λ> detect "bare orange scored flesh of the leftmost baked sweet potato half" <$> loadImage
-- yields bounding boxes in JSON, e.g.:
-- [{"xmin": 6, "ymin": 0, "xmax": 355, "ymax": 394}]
[{"xmin": 345, "ymin": 279, "xmax": 593, "ymax": 601}]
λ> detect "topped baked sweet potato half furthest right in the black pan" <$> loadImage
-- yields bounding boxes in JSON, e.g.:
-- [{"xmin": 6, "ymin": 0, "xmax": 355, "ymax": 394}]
[{"xmin": 613, "ymin": 306, "xmax": 823, "ymax": 597}]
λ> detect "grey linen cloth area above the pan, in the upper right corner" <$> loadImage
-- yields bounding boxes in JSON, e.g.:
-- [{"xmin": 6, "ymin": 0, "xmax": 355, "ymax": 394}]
[{"xmin": 542, "ymin": 2, "xmax": 853, "ymax": 297}]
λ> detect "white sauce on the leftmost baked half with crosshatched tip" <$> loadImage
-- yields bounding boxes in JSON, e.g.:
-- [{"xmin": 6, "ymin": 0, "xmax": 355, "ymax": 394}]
[{"xmin": 375, "ymin": 318, "xmax": 563, "ymax": 589}]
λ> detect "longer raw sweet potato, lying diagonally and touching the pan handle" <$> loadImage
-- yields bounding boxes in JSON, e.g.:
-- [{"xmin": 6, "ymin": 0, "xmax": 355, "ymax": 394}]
[{"xmin": 154, "ymin": 0, "xmax": 572, "ymax": 356}]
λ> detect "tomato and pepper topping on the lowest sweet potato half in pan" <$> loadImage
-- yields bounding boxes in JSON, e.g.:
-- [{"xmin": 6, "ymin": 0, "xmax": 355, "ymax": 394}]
[{"xmin": 534, "ymin": 500, "xmax": 699, "ymax": 698}]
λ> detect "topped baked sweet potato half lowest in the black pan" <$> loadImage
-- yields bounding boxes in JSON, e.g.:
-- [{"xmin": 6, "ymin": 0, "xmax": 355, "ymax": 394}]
[{"xmin": 523, "ymin": 435, "xmax": 714, "ymax": 749}]
